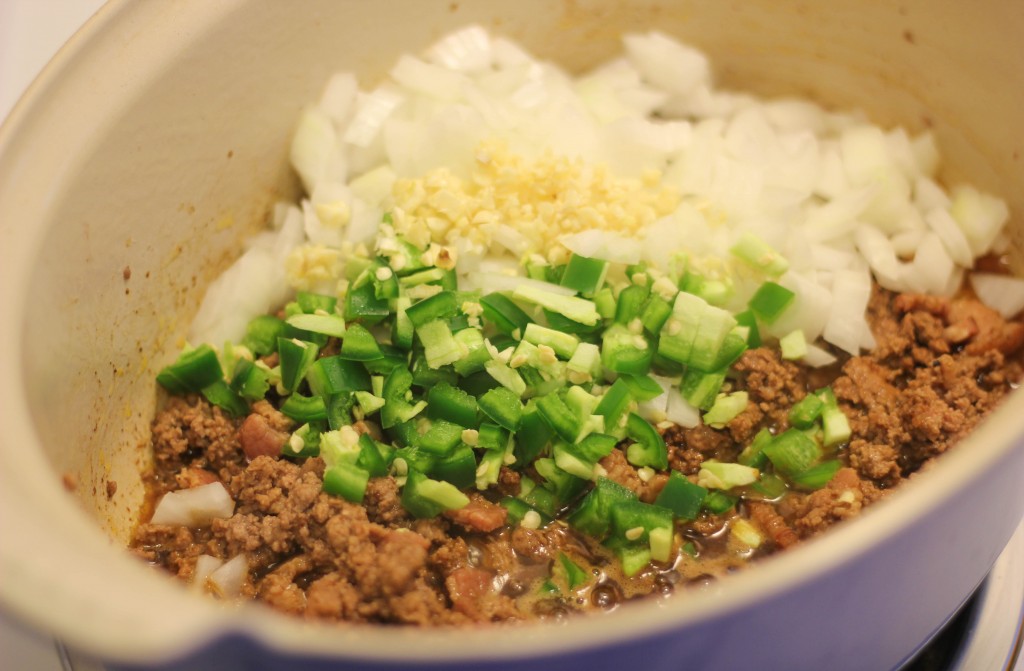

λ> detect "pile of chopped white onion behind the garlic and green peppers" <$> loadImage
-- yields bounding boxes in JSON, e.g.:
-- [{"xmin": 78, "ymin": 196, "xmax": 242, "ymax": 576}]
[{"xmin": 190, "ymin": 27, "xmax": 1024, "ymax": 364}]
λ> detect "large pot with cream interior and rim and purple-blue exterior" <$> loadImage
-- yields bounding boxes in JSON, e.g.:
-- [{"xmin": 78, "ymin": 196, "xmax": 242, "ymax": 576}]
[{"xmin": 0, "ymin": 0, "xmax": 1024, "ymax": 671}]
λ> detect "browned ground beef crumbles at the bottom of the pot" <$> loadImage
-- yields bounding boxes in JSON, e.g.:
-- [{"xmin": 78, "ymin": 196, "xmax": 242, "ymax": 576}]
[{"xmin": 132, "ymin": 290, "xmax": 1024, "ymax": 625}]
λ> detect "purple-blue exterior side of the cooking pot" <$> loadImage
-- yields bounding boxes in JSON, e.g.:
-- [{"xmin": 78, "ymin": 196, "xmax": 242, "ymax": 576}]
[{"xmin": 105, "ymin": 432, "xmax": 1024, "ymax": 671}]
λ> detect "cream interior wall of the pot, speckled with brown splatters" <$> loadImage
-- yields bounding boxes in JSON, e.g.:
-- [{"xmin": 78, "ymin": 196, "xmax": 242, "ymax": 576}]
[{"xmin": 23, "ymin": 0, "xmax": 1024, "ymax": 542}]
